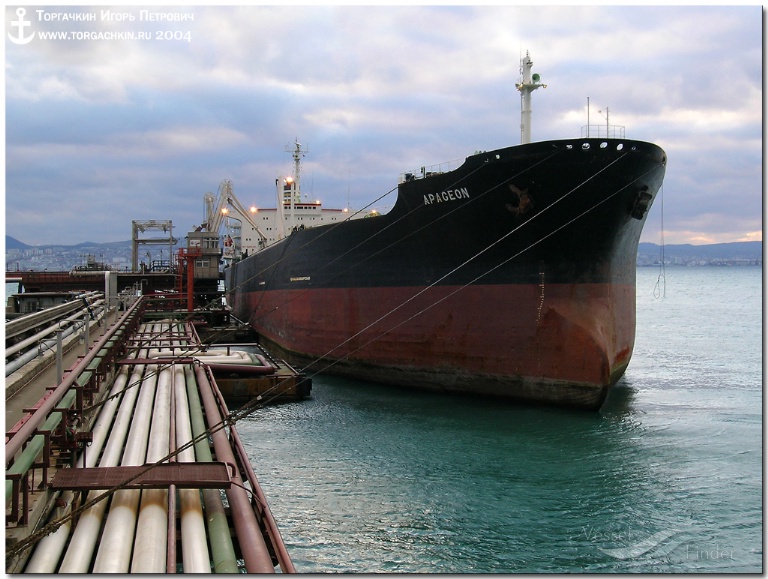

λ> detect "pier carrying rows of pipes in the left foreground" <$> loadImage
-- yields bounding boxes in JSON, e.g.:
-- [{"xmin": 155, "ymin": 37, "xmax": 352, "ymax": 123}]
[{"xmin": 5, "ymin": 292, "xmax": 300, "ymax": 573}]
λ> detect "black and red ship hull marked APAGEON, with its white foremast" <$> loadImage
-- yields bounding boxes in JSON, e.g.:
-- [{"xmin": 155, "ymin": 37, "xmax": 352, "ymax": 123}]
[{"xmin": 225, "ymin": 56, "xmax": 667, "ymax": 409}]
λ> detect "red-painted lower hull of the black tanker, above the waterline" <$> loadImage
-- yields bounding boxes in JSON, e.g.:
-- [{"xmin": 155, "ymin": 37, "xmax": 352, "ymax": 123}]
[{"xmin": 240, "ymin": 282, "xmax": 635, "ymax": 408}]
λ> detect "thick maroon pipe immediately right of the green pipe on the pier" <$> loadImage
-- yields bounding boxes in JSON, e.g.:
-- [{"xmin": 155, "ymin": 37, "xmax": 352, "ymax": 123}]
[{"xmin": 195, "ymin": 367, "xmax": 275, "ymax": 573}]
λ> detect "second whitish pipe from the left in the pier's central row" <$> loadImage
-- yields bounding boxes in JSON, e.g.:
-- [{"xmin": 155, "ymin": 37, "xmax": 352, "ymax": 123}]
[{"xmin": 59, "ymin": 353, "xmax": 150, "ymax": 573}]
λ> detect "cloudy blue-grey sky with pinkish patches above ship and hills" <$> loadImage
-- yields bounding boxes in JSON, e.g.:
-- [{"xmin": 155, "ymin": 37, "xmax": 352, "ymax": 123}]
[{"xmin": 4, "ymin": 4, "xmax": 764, "ymax": 245}]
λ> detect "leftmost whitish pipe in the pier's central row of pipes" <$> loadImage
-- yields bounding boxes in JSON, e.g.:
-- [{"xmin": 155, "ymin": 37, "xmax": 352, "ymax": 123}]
[{"xmin": 24, "ymin": 366, "xmax": 135, "ymax": 573}]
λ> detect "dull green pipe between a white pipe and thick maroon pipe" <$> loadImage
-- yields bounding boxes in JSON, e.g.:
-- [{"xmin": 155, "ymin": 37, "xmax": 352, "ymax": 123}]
[{"xmin": 184, "ymin": 364, "xmax": 240, "ymax": 573}]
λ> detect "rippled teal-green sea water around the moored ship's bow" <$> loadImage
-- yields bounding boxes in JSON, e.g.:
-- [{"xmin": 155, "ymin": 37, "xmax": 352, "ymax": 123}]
[{"xmin": 238, "ymin": 267, "xmax": 763, "ymax": 573}]
